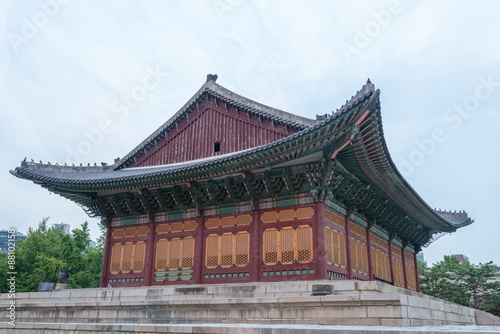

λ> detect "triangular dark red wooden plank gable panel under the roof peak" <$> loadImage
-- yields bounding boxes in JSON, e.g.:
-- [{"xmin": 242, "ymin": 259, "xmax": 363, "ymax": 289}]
[{"xmin": 129, "ymin": 96, "xmax": 298, "ymax": 167}]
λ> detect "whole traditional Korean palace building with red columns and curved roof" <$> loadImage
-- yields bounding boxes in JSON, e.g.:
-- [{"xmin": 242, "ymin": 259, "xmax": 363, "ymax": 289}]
[{"xmin": 11, "ymin": 75, "xmax": 472, "ymax": 291}]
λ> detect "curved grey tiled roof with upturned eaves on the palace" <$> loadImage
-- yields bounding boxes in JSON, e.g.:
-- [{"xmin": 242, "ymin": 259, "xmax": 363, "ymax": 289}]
[{"xmin": 11, "ymin": 80, "xmax": 472, "ymax": 231}]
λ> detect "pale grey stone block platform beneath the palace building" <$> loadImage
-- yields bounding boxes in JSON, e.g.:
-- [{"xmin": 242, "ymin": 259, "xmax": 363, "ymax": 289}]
[{"xmin": 0, "ymin": 281, "xmax": 500, "ymax": 334}]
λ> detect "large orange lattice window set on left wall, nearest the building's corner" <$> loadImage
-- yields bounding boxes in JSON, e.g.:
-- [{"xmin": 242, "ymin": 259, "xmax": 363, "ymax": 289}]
[{"xmin": 263, "ymin": 225, "xmax": 313, "ymax": 265}]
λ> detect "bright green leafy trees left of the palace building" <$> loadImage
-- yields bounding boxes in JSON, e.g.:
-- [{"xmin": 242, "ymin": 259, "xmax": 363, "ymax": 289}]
[{"xmin": 0, "ymin": 218, "xmax": 105, "ymax": 292}]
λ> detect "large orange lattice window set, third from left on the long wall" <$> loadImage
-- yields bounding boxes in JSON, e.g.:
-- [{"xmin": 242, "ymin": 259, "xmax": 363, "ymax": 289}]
[{"xmin": 205, "ymin": 231, "xmax": 250, "ymax": 269}]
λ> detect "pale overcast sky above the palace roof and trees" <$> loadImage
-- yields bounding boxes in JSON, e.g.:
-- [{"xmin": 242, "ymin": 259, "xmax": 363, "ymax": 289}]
[{"xmin": 0, "ymin": 0, "xmax": 500, "ymax": 264}]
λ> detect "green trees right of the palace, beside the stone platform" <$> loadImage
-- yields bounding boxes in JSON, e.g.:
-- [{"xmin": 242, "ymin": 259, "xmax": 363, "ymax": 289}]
[{"xmin": 419, "ymin": 256, "xmax": 500, "ymax": 315}]
